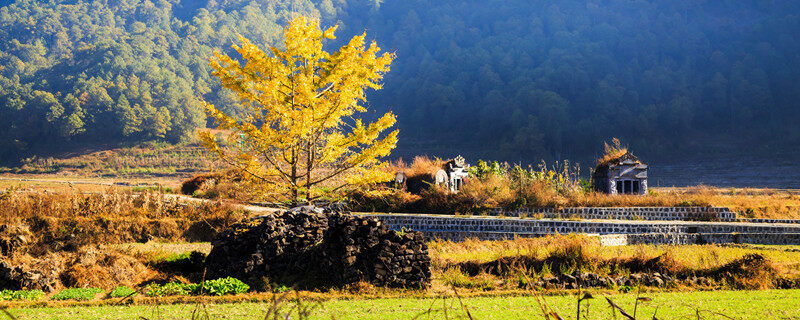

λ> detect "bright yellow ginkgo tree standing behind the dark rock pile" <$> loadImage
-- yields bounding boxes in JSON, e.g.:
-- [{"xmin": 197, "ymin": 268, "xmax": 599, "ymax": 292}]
[{"xmin": 200, "ymin": 16, "xmax": 398, "ymax": 205}]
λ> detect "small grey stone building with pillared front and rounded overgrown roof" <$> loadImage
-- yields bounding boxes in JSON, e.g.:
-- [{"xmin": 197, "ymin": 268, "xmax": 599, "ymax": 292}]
[{"xmin": 592, "ymin": 152, "xmax": 647, "ymax": 195}]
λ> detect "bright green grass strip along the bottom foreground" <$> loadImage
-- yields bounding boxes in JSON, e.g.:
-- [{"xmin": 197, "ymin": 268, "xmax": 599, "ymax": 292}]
[{"xmin": 6, "ymin": 290, "xmax": 800, "ymax": 320}]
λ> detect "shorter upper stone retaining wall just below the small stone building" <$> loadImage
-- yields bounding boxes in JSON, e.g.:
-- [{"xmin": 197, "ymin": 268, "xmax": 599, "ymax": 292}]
[{"xmin": 489, "ymin": 207, "xmax": 736, "ymax": 221}]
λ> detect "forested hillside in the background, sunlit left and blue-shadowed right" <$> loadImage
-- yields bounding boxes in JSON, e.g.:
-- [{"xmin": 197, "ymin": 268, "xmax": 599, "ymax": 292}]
[{"xmin": 0, "ymin": 0, "xmax": 800, "ymax": 162}]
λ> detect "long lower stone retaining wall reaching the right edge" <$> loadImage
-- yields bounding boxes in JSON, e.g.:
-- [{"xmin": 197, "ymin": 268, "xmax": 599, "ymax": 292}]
[{"xmin": 364, "ymin": 214, "xmax": 800, "ymax": 244}]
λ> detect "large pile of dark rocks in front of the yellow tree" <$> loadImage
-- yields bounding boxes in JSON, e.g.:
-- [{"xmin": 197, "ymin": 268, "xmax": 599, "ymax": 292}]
[{"xmin": 206, "ymin": 207, "xmax": 431, "ymax": 287}]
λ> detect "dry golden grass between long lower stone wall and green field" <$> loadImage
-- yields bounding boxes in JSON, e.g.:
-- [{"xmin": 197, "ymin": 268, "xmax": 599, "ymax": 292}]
[{"xmin": 430, "ymin": 235, "xmax": 800, "ymax": 290}]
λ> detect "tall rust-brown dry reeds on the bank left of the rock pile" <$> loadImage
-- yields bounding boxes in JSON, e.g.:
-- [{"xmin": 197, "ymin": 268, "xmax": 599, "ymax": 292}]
[{"xmin": 0, "ymin": 192, "xmax": 246, "ymax": 257}]
